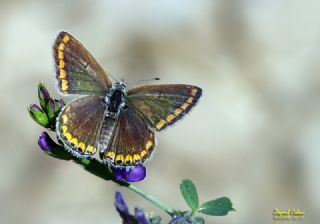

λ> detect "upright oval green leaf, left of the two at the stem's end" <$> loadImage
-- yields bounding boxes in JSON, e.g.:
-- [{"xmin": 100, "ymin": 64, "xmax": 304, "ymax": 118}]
[{"xmin": 180, "ymin": 179, "xmax": 199, "ymax": 210}]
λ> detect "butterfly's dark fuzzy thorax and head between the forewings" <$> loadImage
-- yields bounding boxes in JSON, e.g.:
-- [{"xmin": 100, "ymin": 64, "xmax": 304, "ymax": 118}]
[{"xmin": 105, "ymin": 81, "xmax": 126, "ymax": 117}]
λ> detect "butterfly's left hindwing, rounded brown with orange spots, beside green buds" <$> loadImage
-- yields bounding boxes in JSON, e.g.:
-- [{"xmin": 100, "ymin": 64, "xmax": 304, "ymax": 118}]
[{"xmin": 56, "ymin": 96, "xmax": 105, "ymax": 157}]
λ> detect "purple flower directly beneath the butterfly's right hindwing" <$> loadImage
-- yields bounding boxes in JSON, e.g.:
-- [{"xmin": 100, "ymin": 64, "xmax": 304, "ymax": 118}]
[{"xmin": 112, "ymin": 164, "xmax": 146, "ymax": 182}]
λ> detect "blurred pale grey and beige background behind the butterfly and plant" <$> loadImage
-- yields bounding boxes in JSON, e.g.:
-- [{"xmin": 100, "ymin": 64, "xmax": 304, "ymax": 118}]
[{"xmin": 0, "ymin": 0, "xmax": 320, "ymax": 224}]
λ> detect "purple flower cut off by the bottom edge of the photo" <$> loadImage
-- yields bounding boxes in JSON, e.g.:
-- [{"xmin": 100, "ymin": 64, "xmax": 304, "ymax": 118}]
[{"xmin": 114, "ymin": 191, "xmax": 149, "ymax": 224}]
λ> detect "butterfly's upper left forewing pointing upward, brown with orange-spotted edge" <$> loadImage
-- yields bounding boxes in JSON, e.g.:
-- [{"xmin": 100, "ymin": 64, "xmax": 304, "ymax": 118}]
[{"xmin": 53, "ymin": 32, "xmax": 112, "ymax": 95}]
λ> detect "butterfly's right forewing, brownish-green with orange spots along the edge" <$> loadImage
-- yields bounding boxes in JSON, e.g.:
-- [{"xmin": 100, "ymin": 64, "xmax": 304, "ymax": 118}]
[{"xmin": 127, "ymin": 84, "xmax": 202, "ymax": 131}]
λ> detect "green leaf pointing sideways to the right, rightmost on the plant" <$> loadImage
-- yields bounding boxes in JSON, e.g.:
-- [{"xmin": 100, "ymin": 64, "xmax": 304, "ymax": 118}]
[{"xmin": 198, "ymin": 197, "xmax": 234, "ymax": 216}]
